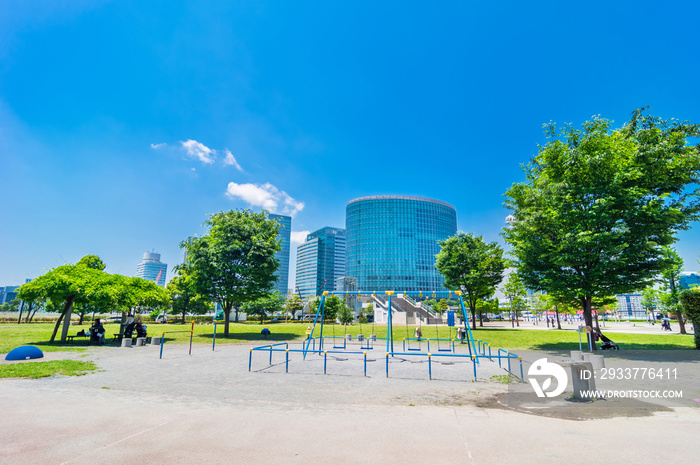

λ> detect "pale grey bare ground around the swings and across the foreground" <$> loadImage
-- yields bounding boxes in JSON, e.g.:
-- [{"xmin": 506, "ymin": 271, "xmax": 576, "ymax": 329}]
[{"xmin": 0, "ymin": 338, "xmax": 700, "ymax": 464}]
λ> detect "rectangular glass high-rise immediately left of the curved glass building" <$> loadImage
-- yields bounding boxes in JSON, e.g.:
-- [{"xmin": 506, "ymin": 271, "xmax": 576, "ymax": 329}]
[{"xmin": 296, "ymin": 227, "xmax": 345, "ymax": 297}]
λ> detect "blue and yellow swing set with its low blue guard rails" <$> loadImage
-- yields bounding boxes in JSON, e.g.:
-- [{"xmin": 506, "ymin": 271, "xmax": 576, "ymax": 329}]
[{"xmin": 248, "ymin": 291, "xmax": 523, "ymax": 380}]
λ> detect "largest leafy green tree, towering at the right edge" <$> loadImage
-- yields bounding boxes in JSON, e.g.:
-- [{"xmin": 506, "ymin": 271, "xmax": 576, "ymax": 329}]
[{"xmin": 503, "ymin": 109, "xmax": 700, "ymax": 348}]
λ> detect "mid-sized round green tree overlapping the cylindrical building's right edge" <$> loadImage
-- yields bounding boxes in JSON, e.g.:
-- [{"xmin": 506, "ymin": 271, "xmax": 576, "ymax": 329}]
[{"xmin": 435, "ymin": 233, "xmax": 506, "ymax": 329}]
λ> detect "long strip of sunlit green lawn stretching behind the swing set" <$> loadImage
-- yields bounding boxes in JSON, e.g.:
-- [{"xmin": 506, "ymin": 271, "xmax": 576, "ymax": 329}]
[{"xmin": 0, "ymin": 322, "xmax": 694, "ymax": 353}]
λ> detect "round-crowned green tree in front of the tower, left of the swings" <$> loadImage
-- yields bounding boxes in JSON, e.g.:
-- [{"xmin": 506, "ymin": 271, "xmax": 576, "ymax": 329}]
[{"xmin": 180, "ymin": 210, "xmax": 280, "ymax": 336}]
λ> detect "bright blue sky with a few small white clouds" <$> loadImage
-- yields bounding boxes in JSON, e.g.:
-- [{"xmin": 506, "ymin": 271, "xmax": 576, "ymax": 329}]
[{"xmin": 0, "ymin": 0, "xmax": 700, "ymax": 286}]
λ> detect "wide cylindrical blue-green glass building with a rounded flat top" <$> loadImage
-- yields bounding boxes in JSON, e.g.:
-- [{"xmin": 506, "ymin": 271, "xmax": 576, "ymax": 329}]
[{"xmin": 345, "ymin": 195, "xmax": 457, "ymax": 292}]
